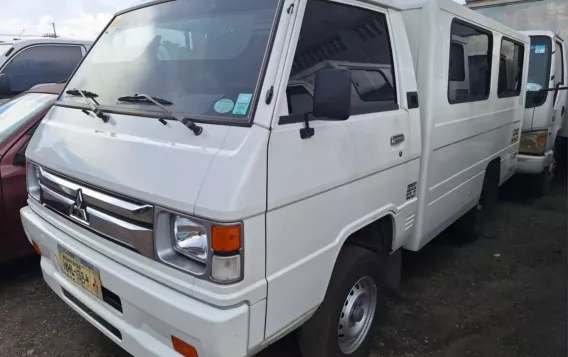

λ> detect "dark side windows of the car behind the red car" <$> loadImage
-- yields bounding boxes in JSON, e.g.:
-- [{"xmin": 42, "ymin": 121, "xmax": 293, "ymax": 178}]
[{"xmin": 2, "ymin": 45, "xmax": 82, "ymax": 94}]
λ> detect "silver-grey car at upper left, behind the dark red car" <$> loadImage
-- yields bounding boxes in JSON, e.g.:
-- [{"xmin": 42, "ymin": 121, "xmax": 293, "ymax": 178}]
[{"xmin": 0, "ymin": 38, "xmax": 92, "ymax": 104}]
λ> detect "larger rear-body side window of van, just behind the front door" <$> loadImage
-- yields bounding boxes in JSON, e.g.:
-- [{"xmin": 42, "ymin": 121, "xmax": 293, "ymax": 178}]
[{"xmin": 448, "ymin": 19, "xmax": 493, "ymax": 104}]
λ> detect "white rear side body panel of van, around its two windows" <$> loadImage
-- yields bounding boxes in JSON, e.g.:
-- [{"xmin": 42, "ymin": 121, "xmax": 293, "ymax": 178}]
[{"xmin": 403, "ymin": 1, "xmax": 528, "ymax": 250}]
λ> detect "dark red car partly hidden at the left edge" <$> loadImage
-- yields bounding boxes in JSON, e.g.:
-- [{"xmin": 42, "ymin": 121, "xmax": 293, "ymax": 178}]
[{"xmin": 0, "ymin": 84, "xmax": 65, "ymax": 262}]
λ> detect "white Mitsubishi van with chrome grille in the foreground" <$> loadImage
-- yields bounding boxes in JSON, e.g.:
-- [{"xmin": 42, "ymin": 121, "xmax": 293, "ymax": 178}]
[{"xmin": 21, "ymin": 0, "xmax": 529, "ymax": 357}]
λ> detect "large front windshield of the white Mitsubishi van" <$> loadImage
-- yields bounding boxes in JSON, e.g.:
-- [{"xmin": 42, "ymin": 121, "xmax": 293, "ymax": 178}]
[{"xmin": 63, "ymin": 0, "xmax": 279, "ymax": 120}]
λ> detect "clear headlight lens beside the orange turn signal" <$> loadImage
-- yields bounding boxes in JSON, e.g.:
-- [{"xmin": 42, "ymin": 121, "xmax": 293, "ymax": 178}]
[{"xmin": 173, "ymin": 216, "xmax": 209, "ymax": 263}]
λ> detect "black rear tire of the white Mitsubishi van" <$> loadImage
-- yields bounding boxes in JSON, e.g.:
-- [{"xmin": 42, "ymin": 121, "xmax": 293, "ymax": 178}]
[{"xmin": 452, "ymin": 168, "xmax": 499, "ymax": 244}]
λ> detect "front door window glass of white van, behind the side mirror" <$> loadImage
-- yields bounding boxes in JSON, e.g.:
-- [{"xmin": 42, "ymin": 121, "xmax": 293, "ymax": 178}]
[{"xmin": 288, "ymin": 0, "xmax": 398, "ymax": 115}]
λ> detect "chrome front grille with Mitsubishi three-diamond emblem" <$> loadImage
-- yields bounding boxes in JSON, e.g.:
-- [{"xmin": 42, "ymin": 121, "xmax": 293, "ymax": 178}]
[{"xmin": 39, "ymin": 168, "xmax": 154, "ymax": 259}]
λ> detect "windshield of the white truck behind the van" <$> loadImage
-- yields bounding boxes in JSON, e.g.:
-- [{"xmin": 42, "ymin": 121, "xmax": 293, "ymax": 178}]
[{"xmin": 527, "ymin": 36, "xmax": 552, "ymax": 92}]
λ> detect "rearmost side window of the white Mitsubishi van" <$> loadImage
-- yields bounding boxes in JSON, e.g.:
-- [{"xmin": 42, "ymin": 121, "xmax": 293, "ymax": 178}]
[{"xmin": 497, "ymin": 38, "xmax": 525, "ymax": 98}]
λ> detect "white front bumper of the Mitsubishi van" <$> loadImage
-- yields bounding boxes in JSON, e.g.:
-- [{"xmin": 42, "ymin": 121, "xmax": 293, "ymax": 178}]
[{"xmin": 21, "ymin": 207, "xmax": 249, "ymax": 357}]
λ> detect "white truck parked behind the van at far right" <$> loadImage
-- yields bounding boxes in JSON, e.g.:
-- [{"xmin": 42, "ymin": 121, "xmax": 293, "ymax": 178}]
[{"xmin": 517, "ymin": 31, "xmax": 568, "ymax": 195}]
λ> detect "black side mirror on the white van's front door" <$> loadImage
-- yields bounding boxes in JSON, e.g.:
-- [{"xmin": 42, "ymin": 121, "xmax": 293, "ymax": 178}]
[{"xmin": 313, "ymin": 69, "xmax": 353, "ymax": 120}]
